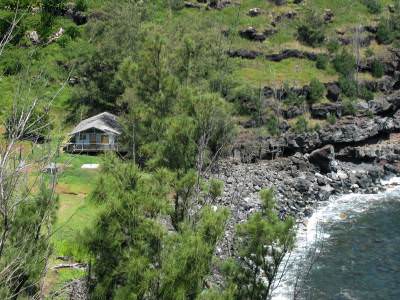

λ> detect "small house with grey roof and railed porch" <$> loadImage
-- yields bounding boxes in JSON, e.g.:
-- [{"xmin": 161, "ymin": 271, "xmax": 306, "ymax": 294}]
[{"xmin": 64, "ymin": 112, "xmax": 122, "ymax": 153}]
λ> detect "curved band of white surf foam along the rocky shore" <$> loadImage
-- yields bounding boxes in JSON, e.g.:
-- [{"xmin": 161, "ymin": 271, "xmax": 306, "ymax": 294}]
[{"xmin": 272, "ymin": 177, "xmax": 400, "ymax": 300}]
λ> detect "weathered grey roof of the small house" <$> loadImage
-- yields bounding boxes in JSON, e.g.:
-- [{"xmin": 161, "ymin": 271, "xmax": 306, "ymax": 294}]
[{"xmin": 70, "ymin": 112, "xmax": 122, "ymax": 135}]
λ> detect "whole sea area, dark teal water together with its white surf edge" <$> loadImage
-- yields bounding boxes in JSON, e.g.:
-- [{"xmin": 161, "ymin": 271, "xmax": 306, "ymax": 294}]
[{"xmin": 272, "ymin": 180, "xmax": 400, "ymax": 300}]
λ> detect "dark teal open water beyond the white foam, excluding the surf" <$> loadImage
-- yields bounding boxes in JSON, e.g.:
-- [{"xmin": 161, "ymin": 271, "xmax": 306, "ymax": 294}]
[{"xmin": 300, "ymin": 198, "xmax": 400, "ymax": 300}]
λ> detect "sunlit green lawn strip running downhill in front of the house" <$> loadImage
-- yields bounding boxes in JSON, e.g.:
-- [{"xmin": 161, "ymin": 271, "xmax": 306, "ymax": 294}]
[{"xmin": 45, "ymin": 154, "xmax": 101, "ymax": 299}]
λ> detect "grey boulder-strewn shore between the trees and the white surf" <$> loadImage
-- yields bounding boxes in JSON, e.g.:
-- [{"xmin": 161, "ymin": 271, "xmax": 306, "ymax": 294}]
[{"xmin": 210, "ymin": 131, "xmax": 400, "ymax": 264}]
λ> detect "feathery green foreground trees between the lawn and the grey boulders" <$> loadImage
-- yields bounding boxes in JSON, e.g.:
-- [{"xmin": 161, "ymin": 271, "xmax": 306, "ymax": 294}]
[{"xmin": 84, "ymin": 157, "xmax": 227, "ymax": 299}]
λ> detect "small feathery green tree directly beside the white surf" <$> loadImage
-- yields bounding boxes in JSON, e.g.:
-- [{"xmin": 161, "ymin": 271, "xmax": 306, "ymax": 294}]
[{"xmin": 224, "ymin": 190, "xmax": 294, "ymax": 299}]
